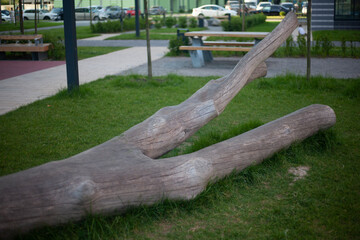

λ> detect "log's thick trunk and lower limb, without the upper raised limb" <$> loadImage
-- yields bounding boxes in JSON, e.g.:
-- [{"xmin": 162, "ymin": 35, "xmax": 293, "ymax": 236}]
[{"xmin": 0, "ymin": 105, "xmax": 336, "ymax": 236}]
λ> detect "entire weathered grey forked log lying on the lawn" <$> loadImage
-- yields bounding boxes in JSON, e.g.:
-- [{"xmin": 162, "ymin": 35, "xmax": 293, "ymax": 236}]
[{"xmin": 0, "ymin": 13, "xmax": 336, "ymax": 238}]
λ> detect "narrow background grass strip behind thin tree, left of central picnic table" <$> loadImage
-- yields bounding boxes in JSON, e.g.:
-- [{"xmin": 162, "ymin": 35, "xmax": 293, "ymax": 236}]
[{"xmin": 106, "ymin": 28, "xmax": 206, "ymax": 40}]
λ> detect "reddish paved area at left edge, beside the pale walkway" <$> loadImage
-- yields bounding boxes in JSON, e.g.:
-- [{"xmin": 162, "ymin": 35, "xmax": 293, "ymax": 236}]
[{"xmin": 0, "ymin": 61, "xmax": 65, "ymax": 80}]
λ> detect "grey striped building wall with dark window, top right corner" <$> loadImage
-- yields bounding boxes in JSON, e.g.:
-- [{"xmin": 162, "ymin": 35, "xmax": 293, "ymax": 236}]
[{"xmin": 311, "ymin": 0, "xmax": 360, "ymax": 30}]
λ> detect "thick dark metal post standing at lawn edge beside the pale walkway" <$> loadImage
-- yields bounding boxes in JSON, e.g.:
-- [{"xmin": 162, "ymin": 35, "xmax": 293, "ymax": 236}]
[{"xmin": 63, "ymin": 0, "xmax": 79, "ymax": 92}]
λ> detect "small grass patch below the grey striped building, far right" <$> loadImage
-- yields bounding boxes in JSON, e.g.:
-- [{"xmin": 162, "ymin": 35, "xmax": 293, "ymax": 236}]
[{"xmin": 313, "ymin": 30, "xmax": 360, "ymax": 42}]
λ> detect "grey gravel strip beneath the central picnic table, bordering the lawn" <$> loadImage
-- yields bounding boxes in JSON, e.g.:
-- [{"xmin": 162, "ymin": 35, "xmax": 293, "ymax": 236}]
[{"xmin": 121, "ymin": 57, "xmax": 360, "ymax": 78}]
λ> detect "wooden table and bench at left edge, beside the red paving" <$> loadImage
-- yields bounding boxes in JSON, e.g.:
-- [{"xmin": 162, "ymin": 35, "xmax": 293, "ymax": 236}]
[{"xmin": 0, "ymin": 34, "xmax": 52, "ymax": 60}]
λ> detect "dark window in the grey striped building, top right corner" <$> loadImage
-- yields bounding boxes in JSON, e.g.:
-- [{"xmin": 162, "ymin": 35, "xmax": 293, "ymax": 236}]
[{"xmin": 335, "ymin": 0, "xmax": 360, "ymax": 20}]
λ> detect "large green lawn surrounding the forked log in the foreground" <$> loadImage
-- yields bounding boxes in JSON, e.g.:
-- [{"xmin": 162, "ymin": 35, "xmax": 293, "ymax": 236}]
[{"xmin": 0, "ymin": 75, "xmax": 360, "ymax": 240}]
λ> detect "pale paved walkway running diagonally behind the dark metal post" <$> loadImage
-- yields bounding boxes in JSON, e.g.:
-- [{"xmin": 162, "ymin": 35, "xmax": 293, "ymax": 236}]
[{"xmin": 0, "ymin": 47, "xmax": 167, "ymax": 115}]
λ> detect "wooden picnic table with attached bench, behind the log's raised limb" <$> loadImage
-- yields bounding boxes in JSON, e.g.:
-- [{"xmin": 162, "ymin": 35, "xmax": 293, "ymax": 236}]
[{"xmin": 179, "ymin": 31, "xmax": 269, "ymax": 68}]
